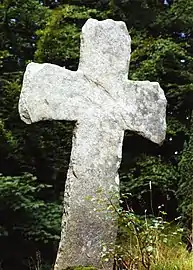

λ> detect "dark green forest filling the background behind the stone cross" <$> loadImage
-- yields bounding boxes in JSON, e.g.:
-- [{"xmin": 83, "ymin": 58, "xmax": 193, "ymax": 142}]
[{"xmin": 0, "ymin": 0, "xmax": 193, "ymax": 270}]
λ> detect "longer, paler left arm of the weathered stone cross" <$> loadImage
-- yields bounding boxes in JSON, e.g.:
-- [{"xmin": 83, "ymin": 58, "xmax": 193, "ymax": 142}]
[{"xmin": 19, "ymin": 63, "xmax": 88, "ymax": 124}]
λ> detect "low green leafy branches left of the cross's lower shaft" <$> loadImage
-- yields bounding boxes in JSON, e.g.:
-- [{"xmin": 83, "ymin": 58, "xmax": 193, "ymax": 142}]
[{"xmin": 0, "ymin": 174, "xmax": 61, "ymax": 243}]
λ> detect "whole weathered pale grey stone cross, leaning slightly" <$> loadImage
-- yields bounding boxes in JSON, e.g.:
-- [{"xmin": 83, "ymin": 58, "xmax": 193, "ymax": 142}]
[{"xmin": 19, "ymin": 19, "xmax": 166, "ymax": 270}]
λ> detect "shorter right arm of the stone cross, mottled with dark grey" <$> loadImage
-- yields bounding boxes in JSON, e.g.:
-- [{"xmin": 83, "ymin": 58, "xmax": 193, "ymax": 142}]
[{"xmin": 124, "ymin": 81, "xmax": 167, "ymax": 144}]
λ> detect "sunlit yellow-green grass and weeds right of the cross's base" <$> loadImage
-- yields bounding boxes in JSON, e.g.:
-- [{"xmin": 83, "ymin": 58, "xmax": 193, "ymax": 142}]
[{"xmin": 116, "ymin": 216, "xmax": 193, "ymax": 270}]
